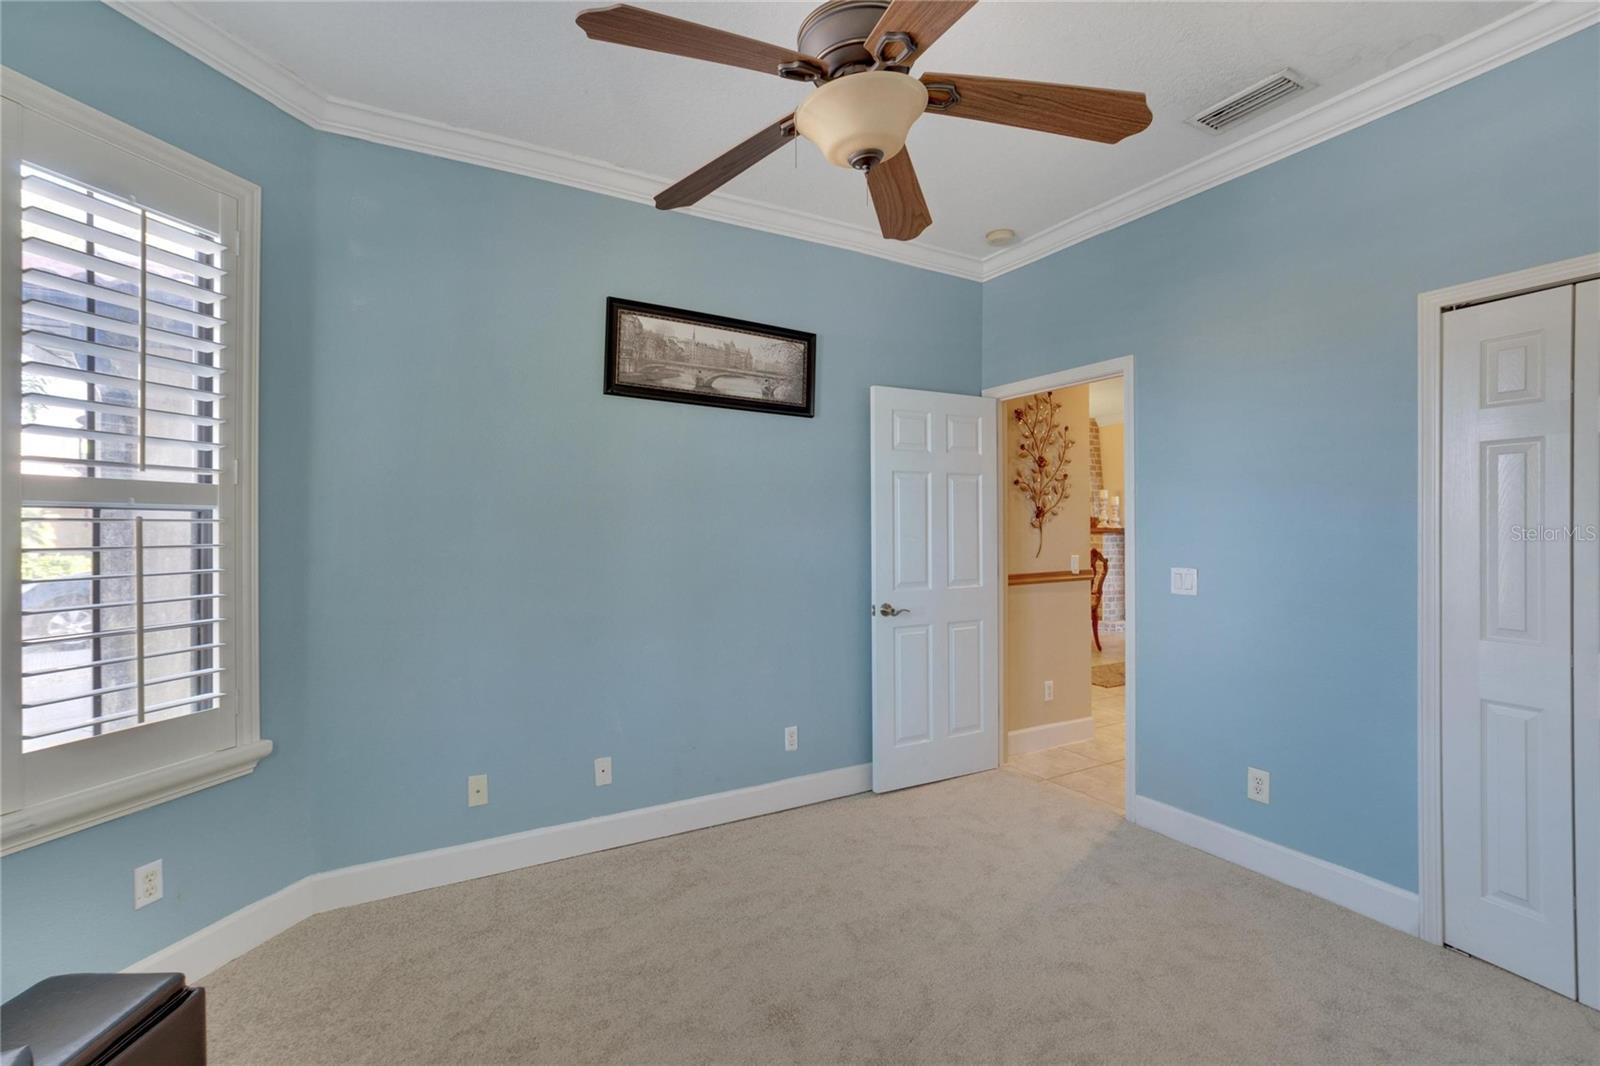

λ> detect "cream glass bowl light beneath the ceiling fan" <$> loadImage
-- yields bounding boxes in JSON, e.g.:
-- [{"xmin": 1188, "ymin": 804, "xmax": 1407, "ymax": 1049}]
[{"xmin": 795, "ymin": 70, "xmax": 928, "ymax": 170}]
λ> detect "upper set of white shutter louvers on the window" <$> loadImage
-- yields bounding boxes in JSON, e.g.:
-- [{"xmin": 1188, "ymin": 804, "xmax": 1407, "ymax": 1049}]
[{"xmin": 21, "ymin": 163, "xmax": 226, "ymax": 486}]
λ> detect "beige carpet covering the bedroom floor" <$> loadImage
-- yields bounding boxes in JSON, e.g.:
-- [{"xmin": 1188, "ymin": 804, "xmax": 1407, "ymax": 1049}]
[{"xmin": 205, "ymin": 771, "xmax": 1600, "ymax": 1066}]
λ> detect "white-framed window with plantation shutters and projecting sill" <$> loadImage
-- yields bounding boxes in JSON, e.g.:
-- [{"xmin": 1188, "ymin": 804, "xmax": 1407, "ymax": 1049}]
[{"xmin": 0, "ymin": 70, "xmax": 270, "ymax": 852}]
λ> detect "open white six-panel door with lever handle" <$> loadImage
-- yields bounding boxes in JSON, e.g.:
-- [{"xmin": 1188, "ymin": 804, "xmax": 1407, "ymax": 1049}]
[{"xmin": 872, "ymin": 386, "xmax": 1000, "ymax": 792}]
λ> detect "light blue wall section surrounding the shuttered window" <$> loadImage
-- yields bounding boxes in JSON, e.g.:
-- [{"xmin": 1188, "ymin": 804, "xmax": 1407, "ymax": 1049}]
[{"xmin": 0, "ymin": 3, "xmax": 315, "ymax": 996}]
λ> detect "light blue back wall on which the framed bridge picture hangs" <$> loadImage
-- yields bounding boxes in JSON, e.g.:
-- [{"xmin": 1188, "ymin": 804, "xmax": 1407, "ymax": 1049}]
[{"xmin": 306, "ymin": 138, "xmax": 981, "ymax": 866}]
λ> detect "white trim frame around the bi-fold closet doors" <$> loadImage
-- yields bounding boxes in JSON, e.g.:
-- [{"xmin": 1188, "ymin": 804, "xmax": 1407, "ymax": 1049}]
[{"xmin": 1416, "ymin": 254, "xmax": 1600, "ymax": 1007}]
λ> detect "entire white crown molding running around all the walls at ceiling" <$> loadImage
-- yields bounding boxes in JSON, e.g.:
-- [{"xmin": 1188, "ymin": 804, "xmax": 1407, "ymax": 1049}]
[{"xmin": 106, "ymin": 0, "xmax": 1600, "ymax": 282}]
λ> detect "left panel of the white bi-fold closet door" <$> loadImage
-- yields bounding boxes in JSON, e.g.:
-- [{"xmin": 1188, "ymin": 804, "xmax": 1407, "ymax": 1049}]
[{"xmin": 1440, "ymin": 287, "xmax": 1578, "ymax": 996}]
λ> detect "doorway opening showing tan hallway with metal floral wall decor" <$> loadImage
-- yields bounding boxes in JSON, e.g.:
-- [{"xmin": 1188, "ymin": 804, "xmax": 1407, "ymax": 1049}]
[{"xmin": 986, "ymin": 357, "xmax": 1134, "ymax": 815}]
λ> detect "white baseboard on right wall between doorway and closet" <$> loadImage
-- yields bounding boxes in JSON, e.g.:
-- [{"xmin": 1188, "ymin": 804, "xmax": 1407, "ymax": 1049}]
[{"xmin": 1133, "ymin": 795, "xmax": 1421, "ymax": 936}]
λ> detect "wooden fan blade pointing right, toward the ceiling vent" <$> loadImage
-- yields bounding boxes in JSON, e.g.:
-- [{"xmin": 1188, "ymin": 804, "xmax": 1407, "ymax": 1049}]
[{"xmin": 922, "ymin": 74, "xmax": 1150, "ymax": 144}]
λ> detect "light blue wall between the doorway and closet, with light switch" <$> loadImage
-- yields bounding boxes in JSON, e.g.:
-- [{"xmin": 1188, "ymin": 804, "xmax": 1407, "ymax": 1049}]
[{"xmin": 984, "ymin": 29, "xmax": 1600, "ymax": 888}]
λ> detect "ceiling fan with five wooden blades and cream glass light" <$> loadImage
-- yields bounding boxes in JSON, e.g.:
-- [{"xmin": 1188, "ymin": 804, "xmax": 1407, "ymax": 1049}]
[{"xmin": 578, "ymin": 0, "xmax": 1150, "ymax": 240}]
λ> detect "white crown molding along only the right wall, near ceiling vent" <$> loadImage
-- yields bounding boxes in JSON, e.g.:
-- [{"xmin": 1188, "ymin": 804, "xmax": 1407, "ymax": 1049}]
[{"xmin": 979, "ymin": 0, "xmax": 1600, "ymax": 282}]
